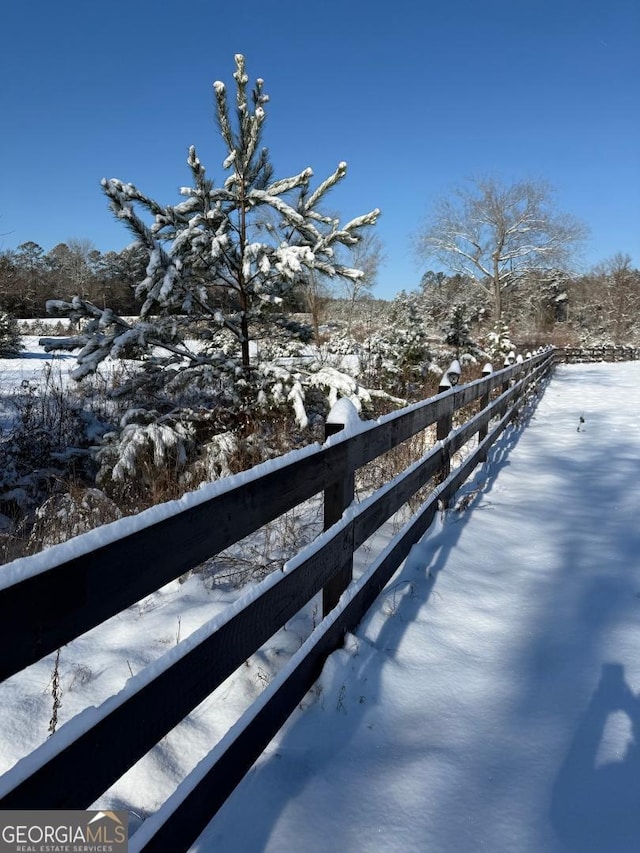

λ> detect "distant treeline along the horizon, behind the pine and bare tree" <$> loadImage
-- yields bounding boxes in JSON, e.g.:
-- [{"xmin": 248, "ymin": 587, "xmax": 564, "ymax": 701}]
[{"xmin": 0, "ymin": 239, "xmax": 640, "ymax": 344}]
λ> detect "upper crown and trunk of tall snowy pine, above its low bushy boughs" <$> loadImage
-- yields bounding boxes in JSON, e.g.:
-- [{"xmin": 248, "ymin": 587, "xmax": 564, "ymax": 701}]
[{"xmin": 51, "ymin": 54, "xmax": 379, "ymax": 378}]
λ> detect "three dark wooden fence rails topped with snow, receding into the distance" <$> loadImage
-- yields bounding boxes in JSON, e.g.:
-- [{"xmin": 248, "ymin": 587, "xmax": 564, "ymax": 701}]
[{"xmin": 0, "ymin": 350, "xmax": 555, "ymax": 851}]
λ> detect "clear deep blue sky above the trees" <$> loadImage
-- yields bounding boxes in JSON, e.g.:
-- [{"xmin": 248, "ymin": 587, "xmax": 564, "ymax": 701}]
[{"xmin": 0, "ymin": 0, "xmax": 640, "ymax": 298}]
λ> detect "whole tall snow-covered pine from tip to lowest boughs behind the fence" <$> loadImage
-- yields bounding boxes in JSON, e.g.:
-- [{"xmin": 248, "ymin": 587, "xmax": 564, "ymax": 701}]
[{"xmin": 42, "ymin": 54, "xmax": 379, "ymax": 494}]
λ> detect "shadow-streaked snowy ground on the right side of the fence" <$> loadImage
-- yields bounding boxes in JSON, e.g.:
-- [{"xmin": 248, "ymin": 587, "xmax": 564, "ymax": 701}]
[{"xmin": 193, "ymin": 363, "xmax": 640, "ymax": 853}]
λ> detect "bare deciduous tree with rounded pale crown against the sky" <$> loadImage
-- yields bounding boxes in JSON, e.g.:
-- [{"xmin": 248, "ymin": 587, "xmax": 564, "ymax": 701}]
[{"xmin": 415, "ymin": 178, "xmax": 586, "ymax": 321}]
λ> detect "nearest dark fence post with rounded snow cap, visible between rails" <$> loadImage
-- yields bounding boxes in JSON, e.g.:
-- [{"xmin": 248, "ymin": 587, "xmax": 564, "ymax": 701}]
[{"xmin": 322, "ymin": 397, "xmax": 360, "ymax": 618}]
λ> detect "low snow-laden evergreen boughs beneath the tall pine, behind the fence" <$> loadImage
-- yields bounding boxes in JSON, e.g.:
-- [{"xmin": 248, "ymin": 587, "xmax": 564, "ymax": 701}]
[{"xmin": 87, "ymin": 322, "xmax": 398, "ymax": 508}]
